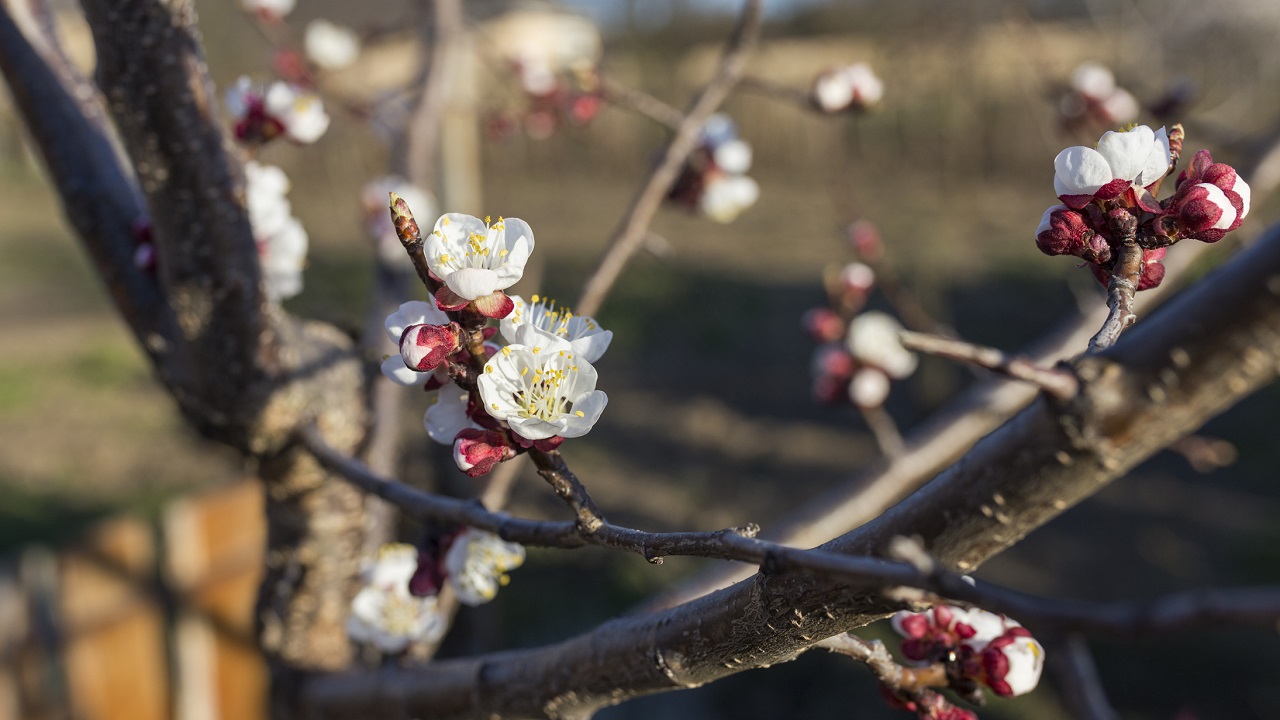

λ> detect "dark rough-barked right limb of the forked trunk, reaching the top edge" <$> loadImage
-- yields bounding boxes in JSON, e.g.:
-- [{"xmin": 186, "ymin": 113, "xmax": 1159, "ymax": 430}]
[{"xmin": 83, "ymin": 0, "xmax": 268, "ymax": 448}]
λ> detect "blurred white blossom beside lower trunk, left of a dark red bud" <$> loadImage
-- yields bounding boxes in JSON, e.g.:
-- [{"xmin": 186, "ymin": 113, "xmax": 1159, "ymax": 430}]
[{"xmin": 347, "ymin": 543, "xmax": 447, "ymax": 652}]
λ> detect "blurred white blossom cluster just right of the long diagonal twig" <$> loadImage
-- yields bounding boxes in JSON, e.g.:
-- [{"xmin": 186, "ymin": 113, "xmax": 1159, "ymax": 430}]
[{"xmin": 667, "ymin": 114, "xmax": 760, "ymax": 223}]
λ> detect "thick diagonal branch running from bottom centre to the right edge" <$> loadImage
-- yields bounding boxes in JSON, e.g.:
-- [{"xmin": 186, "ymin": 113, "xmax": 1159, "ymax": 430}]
[{"xmin": 308, "ymin": 222, "xmax": 1280, "ymax": 717}]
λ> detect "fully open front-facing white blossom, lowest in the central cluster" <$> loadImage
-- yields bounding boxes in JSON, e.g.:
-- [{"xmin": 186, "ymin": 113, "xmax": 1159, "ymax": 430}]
[{"xmin": 477, "ymin": 329, "xmax": 609, "ymax": 439}]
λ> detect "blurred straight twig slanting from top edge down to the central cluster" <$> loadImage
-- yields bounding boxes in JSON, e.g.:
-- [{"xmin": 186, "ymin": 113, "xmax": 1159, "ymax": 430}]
[{"xmin": 576, "ymin": 0, "xmax": 760, "ymax": 315}]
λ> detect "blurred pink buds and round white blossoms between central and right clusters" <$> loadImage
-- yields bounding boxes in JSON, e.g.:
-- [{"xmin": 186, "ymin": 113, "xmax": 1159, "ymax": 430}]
[{"xmin": 803, "ymin": 223, "xmax": 918, "ymax": 409}]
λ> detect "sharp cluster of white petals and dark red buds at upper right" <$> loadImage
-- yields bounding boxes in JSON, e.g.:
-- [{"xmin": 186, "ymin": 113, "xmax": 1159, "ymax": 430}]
[{"xmin": 1036, "ymin": 126, "xmax": 1251, "ymax": 290}]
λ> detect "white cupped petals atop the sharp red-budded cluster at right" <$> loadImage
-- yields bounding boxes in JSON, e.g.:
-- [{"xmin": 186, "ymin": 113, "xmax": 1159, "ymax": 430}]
[{"xmin": 1053, "ymin": 126, "xmax": 1171, "ymax": 197}]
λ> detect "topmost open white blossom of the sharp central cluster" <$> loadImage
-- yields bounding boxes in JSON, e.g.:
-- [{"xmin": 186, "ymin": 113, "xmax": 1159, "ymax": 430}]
[{"xmin": 425, "ymin": 213, "xmax": 534, "ymax": 300}]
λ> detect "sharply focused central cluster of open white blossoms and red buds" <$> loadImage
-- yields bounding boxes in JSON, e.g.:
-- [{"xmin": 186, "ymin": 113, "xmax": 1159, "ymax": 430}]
[{"xmin": 383, "ymin": 207, "xmax": 613, "ymax": 477}]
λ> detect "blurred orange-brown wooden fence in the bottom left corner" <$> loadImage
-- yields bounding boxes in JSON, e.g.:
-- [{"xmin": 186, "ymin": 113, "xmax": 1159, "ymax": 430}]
[{"xmin": 0, "ymin": 482, "xmax": 266, "ymax": 720}]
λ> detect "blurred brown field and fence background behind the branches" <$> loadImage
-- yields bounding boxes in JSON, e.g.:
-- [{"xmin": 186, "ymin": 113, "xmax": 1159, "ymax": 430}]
[{"xmin": 0, "ymin": 0, "xmax": 1280, "ymax": 720}]
